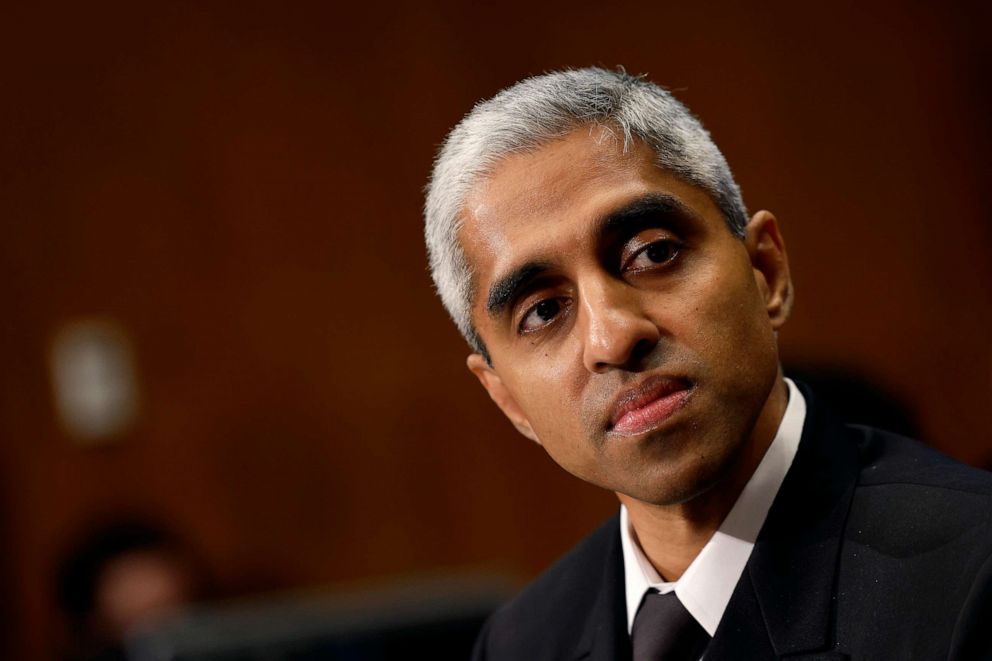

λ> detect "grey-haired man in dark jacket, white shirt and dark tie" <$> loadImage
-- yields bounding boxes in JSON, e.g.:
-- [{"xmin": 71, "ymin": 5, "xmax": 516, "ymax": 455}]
[{"xmin": 425, "ymin": 69, "xmax": 992, "ymax": 661}]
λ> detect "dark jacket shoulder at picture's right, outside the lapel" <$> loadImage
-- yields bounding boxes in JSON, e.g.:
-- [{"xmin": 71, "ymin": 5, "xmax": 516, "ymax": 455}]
[{"xmin": 836, "ymin": 427, "xmax": 992, "ymax": 658}]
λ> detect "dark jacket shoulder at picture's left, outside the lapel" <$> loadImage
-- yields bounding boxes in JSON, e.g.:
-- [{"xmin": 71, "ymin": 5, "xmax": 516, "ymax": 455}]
[{"xmin": 473, "ymin": 516, "xmax": 622, "ymax": 659}]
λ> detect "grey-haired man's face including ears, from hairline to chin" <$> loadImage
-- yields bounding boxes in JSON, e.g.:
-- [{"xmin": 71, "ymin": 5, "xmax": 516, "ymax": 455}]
[{"xmin": 459, "ymin": 127, "xmax": 788, "ymax": 504}]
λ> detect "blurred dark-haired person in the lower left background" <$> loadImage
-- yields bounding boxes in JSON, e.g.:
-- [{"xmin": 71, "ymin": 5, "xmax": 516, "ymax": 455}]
[{"xmin": 57, "ymin": 519, "xmax": 206, "ymax": 661}]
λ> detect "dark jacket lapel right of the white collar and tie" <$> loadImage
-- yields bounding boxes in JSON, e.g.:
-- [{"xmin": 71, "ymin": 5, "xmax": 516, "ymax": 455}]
[{"xmin": 706, "ymin": 389, "xmax": 858, "ymax": 661}]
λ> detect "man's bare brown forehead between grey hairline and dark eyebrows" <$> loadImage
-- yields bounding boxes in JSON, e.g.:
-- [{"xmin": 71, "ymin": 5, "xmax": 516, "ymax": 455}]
[{"xmin": 459, "ymin": 127, "xmax": 722, "ymax": 302}]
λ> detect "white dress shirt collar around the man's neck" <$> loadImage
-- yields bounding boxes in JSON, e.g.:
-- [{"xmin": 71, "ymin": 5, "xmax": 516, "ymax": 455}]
[{"xmin": 620, "ymin": 379, "xmax": 806, "ymax": 636}]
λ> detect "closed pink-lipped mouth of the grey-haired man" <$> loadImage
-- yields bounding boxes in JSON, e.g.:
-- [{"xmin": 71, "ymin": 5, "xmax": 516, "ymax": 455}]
[{"xmin": 607, "ymin": 376, "xmax": 693, "ymax": 436}]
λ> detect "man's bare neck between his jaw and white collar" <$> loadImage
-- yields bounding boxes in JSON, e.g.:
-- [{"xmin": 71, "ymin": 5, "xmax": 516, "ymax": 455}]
[{"xmin": 617, "ymin": 370, "xmax": 789, "ymax": 581}]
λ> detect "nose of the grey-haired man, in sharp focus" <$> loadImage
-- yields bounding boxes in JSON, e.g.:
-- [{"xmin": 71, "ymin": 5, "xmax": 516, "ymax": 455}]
[{"xmin": 579, "ymin": 278, "xmax": 661, "ymax": 374}]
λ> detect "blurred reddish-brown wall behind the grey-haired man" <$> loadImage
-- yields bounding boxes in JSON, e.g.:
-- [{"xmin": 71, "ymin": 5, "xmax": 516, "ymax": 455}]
[{"xmin": 0, "ymin": 1, "xmax": 992, "ymax": 659}]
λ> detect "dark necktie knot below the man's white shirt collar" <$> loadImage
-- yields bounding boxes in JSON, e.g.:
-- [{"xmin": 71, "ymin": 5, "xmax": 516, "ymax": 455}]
[{"xmin": 630, "ymin": 590, "xmax": 710, "ymax": 661}]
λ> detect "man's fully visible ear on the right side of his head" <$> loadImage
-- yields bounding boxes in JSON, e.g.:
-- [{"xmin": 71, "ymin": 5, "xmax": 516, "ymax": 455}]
[{"xmin": 744, "ymin": 211, "xmax": 793, "ymax": 330}]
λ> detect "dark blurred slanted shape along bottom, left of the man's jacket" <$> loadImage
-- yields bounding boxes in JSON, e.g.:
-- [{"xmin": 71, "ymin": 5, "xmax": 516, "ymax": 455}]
[{"xmin": 127, "ymin": 573, "xmax": 512, "ymax": 661}]
